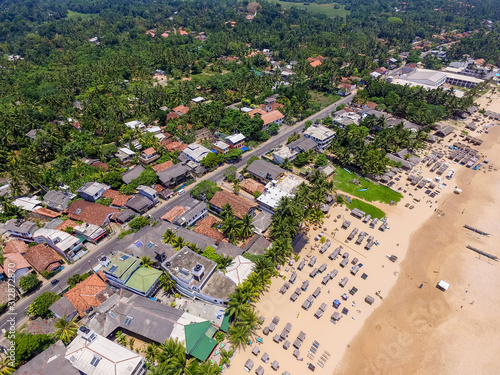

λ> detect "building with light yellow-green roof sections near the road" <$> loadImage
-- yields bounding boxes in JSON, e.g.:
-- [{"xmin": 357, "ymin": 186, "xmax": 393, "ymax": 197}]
[{"xmin": 101, "ymin": 251, "xmax": 162, "ymax": 297}]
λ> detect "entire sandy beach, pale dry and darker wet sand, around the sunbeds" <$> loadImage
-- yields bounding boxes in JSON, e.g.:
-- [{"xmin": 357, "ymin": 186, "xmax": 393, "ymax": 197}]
[{"xmin": 226, "ymin": 97, "xmax": 500, "ymax": 375}]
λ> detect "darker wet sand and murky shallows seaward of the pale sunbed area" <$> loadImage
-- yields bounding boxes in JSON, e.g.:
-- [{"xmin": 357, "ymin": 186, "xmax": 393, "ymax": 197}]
[{"xmin": 335, "ymin": 125, "xmax": 500, "ymax": 375}]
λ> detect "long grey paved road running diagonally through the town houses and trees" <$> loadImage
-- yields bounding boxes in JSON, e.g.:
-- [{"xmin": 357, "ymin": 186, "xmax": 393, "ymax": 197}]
[{"xmin": 0, "ymin": 93, "xmax": 355, "ymax": 341}]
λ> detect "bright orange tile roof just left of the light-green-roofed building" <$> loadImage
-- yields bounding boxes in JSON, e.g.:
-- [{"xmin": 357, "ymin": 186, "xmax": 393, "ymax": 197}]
[{"xmin": 64, "ymin": 272, "xmax": 112, "ymax": 317}]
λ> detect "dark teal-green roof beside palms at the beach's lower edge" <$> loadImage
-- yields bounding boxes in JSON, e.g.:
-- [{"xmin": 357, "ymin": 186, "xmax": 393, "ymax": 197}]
[{"xmin": 184, "ymin": 321, "xmax": 217, "ymax": 361}]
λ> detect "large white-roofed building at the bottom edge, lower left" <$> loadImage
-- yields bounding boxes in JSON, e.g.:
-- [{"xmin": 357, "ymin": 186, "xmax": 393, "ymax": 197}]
[{"xmin": 65, "ymin": 326, "xmax": 145, "ymax": 375}]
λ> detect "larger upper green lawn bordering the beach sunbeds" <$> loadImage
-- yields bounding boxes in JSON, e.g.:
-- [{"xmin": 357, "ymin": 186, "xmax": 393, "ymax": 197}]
[{"xmin": 334, "ymin": 168, "xmax": 403, "ymax": 206}]
